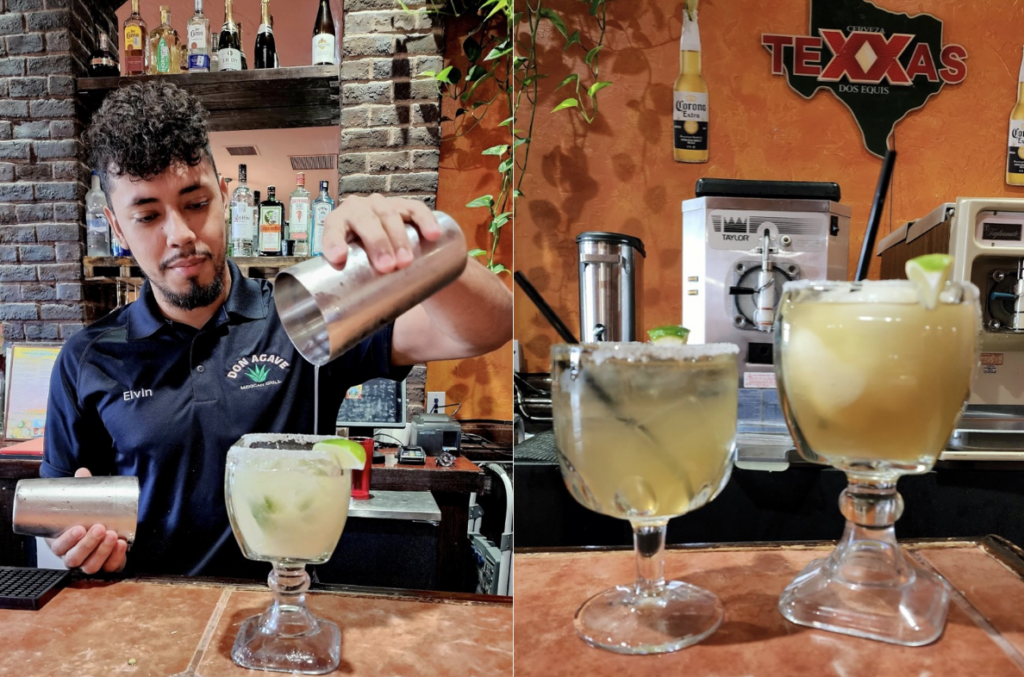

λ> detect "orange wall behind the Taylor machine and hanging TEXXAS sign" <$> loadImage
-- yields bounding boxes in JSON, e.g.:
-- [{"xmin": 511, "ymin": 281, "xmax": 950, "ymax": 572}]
[{"xmin": 515, "ymin": 0, "xmax": 1024, "ymax": 372}]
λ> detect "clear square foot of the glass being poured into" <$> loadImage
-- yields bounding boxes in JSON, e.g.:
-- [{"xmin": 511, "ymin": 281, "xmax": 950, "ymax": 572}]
[{"xmin": 231, "ymin": 615, "xmax": 341, "ymax": 675}]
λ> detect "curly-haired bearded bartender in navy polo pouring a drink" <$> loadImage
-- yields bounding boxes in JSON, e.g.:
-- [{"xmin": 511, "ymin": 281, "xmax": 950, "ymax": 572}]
[{"xmin": 40, "ymin": 82, "xmax": 512, "ymax": 576}]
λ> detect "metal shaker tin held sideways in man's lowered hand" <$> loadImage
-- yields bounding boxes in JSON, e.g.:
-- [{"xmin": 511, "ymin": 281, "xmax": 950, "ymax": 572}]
[{"xmin": 13, "ymin": 476, "xmax": 139, "ymax": 546}]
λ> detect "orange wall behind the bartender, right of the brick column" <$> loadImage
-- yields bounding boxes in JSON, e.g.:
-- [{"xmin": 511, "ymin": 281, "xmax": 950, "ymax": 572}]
[{"xmin": 427, "ymin": 14, "xmax": 512, "ymax": 420}]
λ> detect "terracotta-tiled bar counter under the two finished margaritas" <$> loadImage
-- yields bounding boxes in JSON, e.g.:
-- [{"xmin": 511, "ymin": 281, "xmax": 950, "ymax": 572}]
[{"xmin": 515, "ymin": 537, "xmax": 1024, "ymax": 677}]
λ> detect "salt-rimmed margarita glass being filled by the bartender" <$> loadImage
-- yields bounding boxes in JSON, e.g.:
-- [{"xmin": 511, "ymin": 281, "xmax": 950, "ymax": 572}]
[{"xmin": 224, "ymin": 434, "xmax": 352, "ymax": 675}]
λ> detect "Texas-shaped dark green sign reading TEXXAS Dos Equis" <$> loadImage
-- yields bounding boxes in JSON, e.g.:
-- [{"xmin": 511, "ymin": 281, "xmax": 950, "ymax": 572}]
[{"xmin": 761, "ymin": 0, "xmax": 967, "ymax": 157}]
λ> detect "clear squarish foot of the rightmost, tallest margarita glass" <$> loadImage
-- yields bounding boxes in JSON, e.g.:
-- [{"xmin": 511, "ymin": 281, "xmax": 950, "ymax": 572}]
[{"xmin": 778, "ymin": 557, "xmax": 949, "ymax": 646}]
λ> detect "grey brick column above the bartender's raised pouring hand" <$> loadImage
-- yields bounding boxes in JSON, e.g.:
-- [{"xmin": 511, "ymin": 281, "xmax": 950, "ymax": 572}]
[{"xmin": 338, "ymin": 0, "xmax": 444, "ymax": 207}]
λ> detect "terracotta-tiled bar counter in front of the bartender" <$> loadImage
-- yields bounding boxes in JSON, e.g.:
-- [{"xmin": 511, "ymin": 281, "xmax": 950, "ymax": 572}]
[{"xmin": 0, "ymin": 579, "xmax": 512, "ymax": 677}]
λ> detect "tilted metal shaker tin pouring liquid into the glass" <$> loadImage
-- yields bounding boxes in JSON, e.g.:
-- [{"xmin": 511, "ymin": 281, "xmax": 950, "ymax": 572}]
[{"xmin": 273, "ymin": 212, "xmax": 468, "ymax": 366}]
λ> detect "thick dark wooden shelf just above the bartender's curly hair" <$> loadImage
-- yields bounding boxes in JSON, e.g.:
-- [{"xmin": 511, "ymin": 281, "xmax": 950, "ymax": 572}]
[{"xmin": 78, "ymin": 66, "xmax": 341, "ymax": 131}]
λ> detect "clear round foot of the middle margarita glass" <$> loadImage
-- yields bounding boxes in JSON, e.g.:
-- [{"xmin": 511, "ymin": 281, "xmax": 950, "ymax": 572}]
[{"xmin": 574, "ymin": 581, "xmax": 723, "ymax": 653}]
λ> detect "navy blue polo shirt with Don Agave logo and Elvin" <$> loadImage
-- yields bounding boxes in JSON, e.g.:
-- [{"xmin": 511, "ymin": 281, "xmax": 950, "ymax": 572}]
[{"xmin": 40, "ymin": 261, "xmax": 409, "ymax": 577}]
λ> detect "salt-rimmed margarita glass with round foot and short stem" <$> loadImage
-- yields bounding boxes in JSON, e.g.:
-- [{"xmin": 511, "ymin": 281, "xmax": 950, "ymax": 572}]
[{"xmin": 552, "ymin": 343, "xmax": 738, "ymax": 653}]
